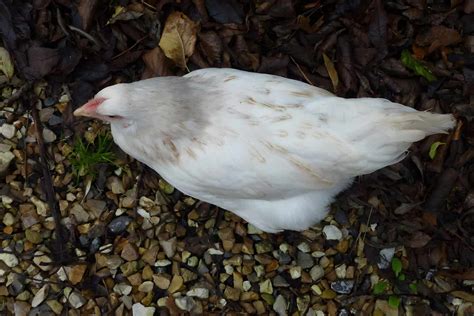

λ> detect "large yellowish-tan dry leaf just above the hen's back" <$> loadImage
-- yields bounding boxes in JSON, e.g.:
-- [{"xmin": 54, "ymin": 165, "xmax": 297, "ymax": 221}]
[{"xmin": 159, "ymin": 12, "xmax": 199, "ymax": 68}]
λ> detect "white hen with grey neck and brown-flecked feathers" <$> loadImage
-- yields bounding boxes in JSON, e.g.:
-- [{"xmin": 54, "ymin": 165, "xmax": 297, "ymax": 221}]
[{"xmin": 74, "ymin": 68, "xmax": 455, "ymax": 232}]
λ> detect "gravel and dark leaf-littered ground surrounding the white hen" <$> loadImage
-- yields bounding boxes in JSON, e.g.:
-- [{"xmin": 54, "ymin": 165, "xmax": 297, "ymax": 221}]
[{"xmin": 0, "ymin": 0, "xmax": 474, "ymax": 315}]
